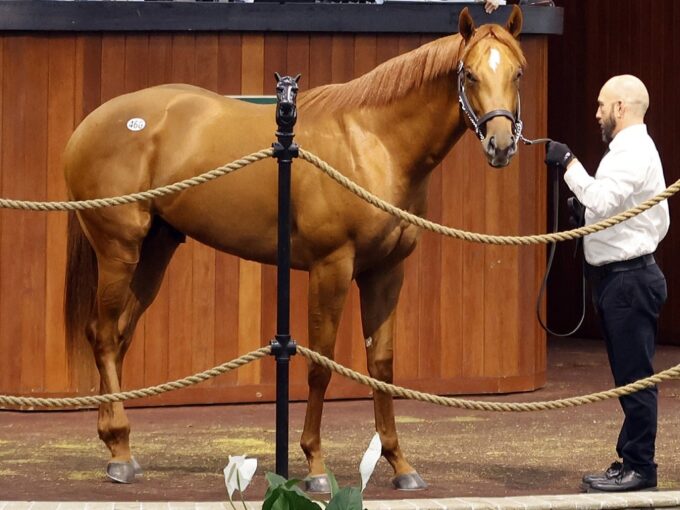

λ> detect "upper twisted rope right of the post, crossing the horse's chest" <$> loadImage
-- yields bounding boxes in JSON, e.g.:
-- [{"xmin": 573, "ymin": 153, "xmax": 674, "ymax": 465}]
[{"xmin": 300, "ymin": 149, "xmax": 680, "ymax": 245}]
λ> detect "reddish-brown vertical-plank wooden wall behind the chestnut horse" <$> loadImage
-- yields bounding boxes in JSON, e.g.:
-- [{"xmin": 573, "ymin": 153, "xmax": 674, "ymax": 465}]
[{"xmin": 0, "ymin": 33, "xmax": 547, "ymax": 405}]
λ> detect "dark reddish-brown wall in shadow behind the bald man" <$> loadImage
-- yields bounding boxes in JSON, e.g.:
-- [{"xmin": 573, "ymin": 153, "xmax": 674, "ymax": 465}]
[{"xmin": 548, "ymin": 0, "xmax": 680, "ymax": 345}]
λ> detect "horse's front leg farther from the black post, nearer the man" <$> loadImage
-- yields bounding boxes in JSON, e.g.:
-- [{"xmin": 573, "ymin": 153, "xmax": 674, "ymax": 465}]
[{"xmin": 357, "ymin": 263, "xmax": 427, "ymax": 490}]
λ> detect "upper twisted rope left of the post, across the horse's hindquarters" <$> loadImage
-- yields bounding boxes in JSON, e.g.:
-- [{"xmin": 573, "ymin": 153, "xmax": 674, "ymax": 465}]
[{"xmin": 0, "ymin": 148, "xmax": 274, "ymax": 211}]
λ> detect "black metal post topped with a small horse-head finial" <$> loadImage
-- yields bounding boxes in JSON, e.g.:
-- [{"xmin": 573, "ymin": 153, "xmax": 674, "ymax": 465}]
[{"xmin": 271, "ymin": 73, "xmax": 300, "ymax": 478}]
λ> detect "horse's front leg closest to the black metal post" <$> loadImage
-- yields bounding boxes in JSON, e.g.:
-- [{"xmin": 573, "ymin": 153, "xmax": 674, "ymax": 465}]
[{"xmin": 300, "ymin": 257, "xmax": 353, "ymax": 492}]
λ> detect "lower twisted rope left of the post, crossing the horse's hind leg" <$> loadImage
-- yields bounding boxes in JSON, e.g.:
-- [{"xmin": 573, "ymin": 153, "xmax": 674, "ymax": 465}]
[{"xmin": 0, "ymin": 346, "xmax": 272, "ymax": 408}]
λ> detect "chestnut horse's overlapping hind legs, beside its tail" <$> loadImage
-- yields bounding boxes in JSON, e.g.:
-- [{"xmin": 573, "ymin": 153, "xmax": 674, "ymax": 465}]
[{"xmin": 85, "ymin": 212, "xmax": 180, "ymax": 483}]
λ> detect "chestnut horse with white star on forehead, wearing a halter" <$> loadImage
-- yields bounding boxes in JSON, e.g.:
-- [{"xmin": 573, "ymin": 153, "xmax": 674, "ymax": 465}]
[{"xmin": 64, "ymin": 6, "xmax": 526, "ymax": 492}]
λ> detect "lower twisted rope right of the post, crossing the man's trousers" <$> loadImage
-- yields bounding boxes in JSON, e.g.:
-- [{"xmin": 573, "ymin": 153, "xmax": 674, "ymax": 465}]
[{"xmin": 297, "ymin": 345, "xmax": 680, "ymax": 412}]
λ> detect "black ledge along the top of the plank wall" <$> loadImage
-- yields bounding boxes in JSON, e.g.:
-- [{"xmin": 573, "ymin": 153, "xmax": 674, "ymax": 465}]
[{"xmin": 0, "ymin": 0, "xmax": 563, "ymax": 34}]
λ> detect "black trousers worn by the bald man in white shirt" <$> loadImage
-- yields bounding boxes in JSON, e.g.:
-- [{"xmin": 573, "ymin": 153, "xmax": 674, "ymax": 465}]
[{"xmin": 589, "ymin": 263, "xmax": 667, "ymax": 475}]
